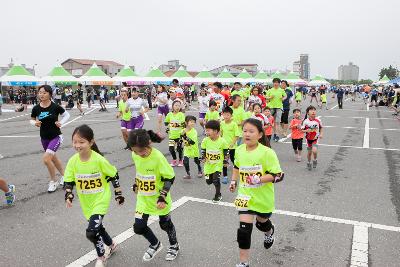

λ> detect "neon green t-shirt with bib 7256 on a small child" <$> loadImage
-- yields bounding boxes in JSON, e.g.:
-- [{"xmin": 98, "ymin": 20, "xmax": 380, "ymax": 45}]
[{"xmin": 201, "ymin": 137, "xmax": 228, "ymax": 175}]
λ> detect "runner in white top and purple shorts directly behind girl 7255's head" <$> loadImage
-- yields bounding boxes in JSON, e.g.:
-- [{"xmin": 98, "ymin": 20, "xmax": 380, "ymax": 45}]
[{"xmin": 125, "ymin": 87, "xmax": 149, "ymax": 129}]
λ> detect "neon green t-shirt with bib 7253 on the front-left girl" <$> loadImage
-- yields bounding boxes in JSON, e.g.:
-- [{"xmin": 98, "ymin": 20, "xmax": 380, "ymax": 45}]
[{"xmin": 64, "ymin": 151, "xmax": 117, "ymax": 220}]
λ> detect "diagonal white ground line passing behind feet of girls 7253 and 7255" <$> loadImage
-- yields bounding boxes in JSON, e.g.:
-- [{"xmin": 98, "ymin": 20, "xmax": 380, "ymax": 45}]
[{"xmin": 67, "ymin": 197, "xmax": 188, "ymax": 267}]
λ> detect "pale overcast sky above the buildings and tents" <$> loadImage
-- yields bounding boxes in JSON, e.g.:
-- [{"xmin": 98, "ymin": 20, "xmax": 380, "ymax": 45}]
[{"xmin": 0, "ymin": 0, "xmax": 400, "ymax": 80}]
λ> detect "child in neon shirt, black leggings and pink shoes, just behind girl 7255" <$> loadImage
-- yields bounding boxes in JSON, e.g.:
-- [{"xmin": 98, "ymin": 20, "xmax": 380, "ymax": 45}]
[{"xmin": 165, "ymin": 100, "xmax": 185, "ymax": 167}]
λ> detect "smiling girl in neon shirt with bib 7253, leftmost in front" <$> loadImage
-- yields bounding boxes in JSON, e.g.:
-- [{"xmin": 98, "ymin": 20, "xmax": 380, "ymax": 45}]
[{"xmin": 65, "ymin": 124, "xmax": 125, "ymax": 267}]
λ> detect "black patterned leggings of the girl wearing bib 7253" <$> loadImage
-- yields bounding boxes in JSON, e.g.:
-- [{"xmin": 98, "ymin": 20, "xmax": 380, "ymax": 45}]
[{"xmin": 86, "ymin": 214, "xmax": 112, "ymax": 257}]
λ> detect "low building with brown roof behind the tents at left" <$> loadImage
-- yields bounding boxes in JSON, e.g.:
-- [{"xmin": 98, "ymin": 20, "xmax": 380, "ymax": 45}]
[{"xmin": 61, "ymin": 58, "xmax": 124, "ymax": 77}]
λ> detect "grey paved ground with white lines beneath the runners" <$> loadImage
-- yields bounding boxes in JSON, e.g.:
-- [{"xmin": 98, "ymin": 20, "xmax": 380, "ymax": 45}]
[{"xmin": 0, "ymin": 93, "xmax": 400, "ymax": 266}]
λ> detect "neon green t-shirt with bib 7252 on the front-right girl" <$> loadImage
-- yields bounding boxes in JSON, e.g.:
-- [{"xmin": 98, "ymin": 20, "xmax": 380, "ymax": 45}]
[{"xmin": 234, "ymin": 144, "xmax": 282, "ymax": 213}]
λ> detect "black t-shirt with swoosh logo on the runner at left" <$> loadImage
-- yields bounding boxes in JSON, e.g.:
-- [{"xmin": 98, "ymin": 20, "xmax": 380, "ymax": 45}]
[{"xmin": 31, "ymin": 102, "xmax": 65, "ymax": 140}]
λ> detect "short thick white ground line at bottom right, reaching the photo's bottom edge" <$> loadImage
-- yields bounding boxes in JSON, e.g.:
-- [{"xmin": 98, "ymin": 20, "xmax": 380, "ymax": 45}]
[{"xmin": 350, "ymin": 225, "xmax": 368, "ymax": 267}]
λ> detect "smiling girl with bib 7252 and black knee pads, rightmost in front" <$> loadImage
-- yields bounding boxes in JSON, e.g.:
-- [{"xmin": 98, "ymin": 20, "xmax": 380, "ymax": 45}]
[{"xmin": 229, "ymin": 118, "xmax": 284, "ymax": 267}]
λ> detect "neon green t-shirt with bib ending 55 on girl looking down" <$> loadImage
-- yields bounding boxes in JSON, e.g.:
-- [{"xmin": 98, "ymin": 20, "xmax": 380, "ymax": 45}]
[{"xmin": 132, "ymin": 147, "xmax": 175, "ymax": 217}]
